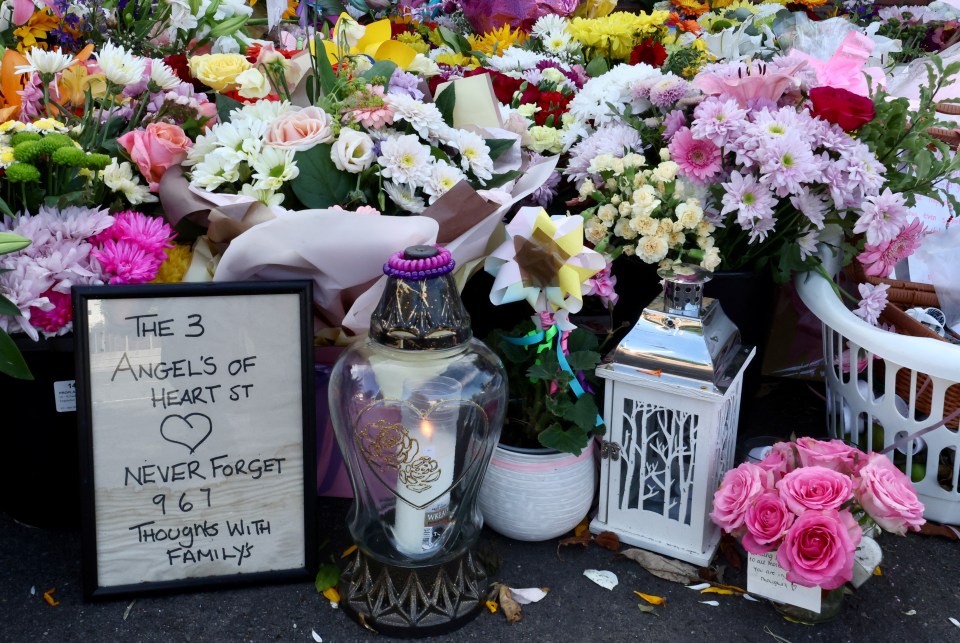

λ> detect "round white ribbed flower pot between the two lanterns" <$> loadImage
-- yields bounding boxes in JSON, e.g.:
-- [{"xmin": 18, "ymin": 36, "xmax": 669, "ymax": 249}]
[{"xmin": 479, "ymin": 444, "xmax": 597, "ymax": 541}]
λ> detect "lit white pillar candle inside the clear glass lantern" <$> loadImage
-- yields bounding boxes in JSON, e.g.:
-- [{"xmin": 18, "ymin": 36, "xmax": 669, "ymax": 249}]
[{"xmin": 393, "ymin": 377, "xmax": 461, "ymax": 558}]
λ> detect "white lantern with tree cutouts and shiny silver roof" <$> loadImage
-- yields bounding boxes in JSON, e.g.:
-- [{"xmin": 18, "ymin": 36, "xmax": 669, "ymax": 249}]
[{"xmin": 590, "ymin": 266, "xmax": 756, "ymax": 565}]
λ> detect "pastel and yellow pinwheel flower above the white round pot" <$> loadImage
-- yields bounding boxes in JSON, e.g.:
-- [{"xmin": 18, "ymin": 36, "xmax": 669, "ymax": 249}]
[{"xmin": 484, "ymin": 208, "xmax": 606, "ymax": 313}]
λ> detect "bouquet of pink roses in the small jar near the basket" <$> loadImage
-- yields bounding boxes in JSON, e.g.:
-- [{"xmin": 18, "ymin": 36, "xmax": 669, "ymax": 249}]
[{"xmin": 710, "ymin": 438, "xmax": 924, "ymax": 589}]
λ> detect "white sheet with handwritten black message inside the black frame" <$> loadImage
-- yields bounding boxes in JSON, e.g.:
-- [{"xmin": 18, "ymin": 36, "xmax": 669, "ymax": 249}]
[{"xmin": 88, "ymin": 294, "xmax": 305, "ymax": 586}]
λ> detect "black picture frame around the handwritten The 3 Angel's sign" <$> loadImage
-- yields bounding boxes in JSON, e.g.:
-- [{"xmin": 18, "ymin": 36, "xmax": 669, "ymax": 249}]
[{"xmin": 72, "ymin": 280, "xmax": 317, "ymax": 601}]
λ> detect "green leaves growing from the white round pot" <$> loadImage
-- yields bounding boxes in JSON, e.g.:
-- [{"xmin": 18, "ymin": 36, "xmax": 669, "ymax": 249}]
[{"xmin": 488, "ymin": 322, "xmax": 603, "ymax": 455}]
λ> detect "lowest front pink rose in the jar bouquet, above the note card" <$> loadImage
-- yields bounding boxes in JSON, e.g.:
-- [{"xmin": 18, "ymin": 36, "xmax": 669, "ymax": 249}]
[{"xmin": 777, "ymin": 509, "xmax": 860, "ymax": 589}]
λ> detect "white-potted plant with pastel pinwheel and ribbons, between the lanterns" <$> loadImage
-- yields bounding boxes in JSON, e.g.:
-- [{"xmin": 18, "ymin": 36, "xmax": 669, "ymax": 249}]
[{"xmin": 479, "ymin": 208, "xmax": 606, "ymax": 541}]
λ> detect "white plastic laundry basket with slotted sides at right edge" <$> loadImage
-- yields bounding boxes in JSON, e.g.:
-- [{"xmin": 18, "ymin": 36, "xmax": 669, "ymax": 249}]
[{"xmin": 795, "ymin": 252, "xmax": 960, "ymax": 524}]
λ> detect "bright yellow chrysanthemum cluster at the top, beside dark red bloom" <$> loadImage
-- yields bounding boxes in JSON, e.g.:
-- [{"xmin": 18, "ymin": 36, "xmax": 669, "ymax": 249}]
[{"xmin": 567, "ymin": 11, "xmax": 670, "ymax": 60}]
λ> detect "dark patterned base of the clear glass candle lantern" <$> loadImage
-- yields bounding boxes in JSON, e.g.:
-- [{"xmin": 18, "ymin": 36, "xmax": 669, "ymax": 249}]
[{"xmin": 340, "ymin": 550, "xmax": 487, "ymax": 638}]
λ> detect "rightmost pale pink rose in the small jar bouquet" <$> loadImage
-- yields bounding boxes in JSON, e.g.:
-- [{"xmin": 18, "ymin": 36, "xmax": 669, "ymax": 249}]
[{"xmin": 856, "ymin": 453, "xmax": 925, "ymax": 535}]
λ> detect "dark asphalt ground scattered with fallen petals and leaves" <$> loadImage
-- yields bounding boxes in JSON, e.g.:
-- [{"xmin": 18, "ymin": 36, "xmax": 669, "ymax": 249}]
[{"xmin": 0, "ymin": 380, "xmax": 960, "ymax": 643}]
